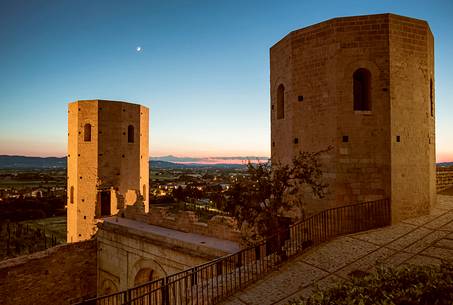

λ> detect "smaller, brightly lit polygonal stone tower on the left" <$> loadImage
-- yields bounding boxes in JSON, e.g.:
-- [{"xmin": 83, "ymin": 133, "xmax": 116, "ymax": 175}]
[{"xmin": 67, "ymin": 100, "xmax": 149, "ymax": 242}]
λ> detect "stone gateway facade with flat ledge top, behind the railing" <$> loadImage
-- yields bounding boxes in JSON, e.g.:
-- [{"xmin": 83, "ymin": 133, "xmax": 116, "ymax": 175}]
[{"xmin": 96, "ymin": 216, "xmax": 240, "ymax": 295}]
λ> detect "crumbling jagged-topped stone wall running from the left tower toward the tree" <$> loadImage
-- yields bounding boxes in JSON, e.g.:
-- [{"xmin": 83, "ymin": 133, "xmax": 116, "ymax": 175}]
[{"xmin": 124, "ymin": 206, "xmax": 241, "ymax": 242}]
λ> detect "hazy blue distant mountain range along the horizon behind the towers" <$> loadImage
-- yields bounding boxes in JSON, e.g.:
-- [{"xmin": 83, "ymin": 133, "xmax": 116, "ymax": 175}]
[{"xmin": 0, "ymin": 155, "xmax": 453, "ymax": 169}]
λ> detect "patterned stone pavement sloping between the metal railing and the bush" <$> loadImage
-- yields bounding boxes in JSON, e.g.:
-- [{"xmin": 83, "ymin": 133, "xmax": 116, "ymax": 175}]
[{"xmin": 222, "ymin": 195, "xmax": 453, "ymax": 305}]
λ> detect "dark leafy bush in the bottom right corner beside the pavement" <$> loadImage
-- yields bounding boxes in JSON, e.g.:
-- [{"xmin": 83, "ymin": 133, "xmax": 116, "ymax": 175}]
[{"xmin": 290, "ymin": 262, "xmax": 453, "ymax": 305}]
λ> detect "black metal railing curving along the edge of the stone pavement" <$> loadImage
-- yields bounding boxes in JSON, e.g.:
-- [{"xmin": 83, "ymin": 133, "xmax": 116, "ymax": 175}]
[{"xmin": 78, "ymin": 199, "xmax": 390, "ymax": 305}]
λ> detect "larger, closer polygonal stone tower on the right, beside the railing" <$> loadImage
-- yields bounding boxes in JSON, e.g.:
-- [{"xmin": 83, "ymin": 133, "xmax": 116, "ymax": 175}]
[{"xmin": 270, "ymin": 14, "xmax": 436, "ymax": 223}]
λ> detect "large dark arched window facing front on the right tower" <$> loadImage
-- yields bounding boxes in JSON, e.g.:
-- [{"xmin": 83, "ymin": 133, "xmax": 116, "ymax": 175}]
[{"xmin": 353, "ymin": 68, "xmax": 371, "ymax": 110}]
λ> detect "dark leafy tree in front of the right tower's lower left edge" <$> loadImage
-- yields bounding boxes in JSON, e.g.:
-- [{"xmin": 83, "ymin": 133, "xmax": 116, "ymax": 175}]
[{"xmin": 226, "ymin": 147, "xmax": 331, "ymax": 243}]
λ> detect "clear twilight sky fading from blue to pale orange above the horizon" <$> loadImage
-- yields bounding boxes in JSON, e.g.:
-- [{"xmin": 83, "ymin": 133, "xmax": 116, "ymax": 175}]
[{"xmin": 0, "ymin": 0, "xmax": 453, "ymax": 161}]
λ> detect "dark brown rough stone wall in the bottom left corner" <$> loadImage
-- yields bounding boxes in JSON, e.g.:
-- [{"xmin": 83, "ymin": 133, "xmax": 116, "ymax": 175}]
[{"xmin": 0, "ymin": 240, "xmax": 97, "ymax": 305}]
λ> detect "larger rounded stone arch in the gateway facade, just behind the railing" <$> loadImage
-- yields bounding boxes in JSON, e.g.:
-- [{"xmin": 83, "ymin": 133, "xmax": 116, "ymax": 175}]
[{"xmin": 128, "ymin": 258, "xmax": 167, "ymax": 287}]
